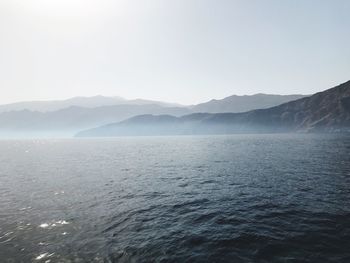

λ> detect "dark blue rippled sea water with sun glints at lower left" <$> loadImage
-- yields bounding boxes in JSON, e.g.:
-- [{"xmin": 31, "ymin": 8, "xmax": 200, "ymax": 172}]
[{"xmin": 0, "ymin": 135, "xmax": 350, "ymax": 262}]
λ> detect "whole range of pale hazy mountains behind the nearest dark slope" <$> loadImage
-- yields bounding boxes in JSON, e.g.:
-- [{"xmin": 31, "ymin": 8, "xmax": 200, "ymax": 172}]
[{"xmin": 0, "ymin": 94, "xmax": 305, "ymax": 137}]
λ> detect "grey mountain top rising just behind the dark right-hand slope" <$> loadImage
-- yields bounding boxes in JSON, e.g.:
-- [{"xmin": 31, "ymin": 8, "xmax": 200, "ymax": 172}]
[{"xmin": 191, "ymin": 93, "xmax": 307, "ymax": 113}]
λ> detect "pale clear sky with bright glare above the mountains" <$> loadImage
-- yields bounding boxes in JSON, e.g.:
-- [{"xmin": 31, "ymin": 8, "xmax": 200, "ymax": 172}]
[{"xmin": 0, "ymin": 0, "xmax": 350, "ymax": 104}]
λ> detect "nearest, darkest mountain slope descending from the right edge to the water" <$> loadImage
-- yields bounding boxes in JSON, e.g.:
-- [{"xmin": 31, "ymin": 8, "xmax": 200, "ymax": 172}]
[{"xmin": 77, "ymin": 81, "xmax": 350, "ymax": 137}]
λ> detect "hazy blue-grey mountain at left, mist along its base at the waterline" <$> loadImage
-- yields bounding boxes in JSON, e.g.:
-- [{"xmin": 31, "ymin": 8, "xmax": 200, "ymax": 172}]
[{"xmin": 0, "ymin": 104, "xmax": 190, "ymax": 137}]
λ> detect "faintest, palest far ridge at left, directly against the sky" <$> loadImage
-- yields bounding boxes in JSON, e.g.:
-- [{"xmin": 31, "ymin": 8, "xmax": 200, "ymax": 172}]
[{"xmin": 0, "ymin": 96, "xmax": 186, "ymax": 113}]
